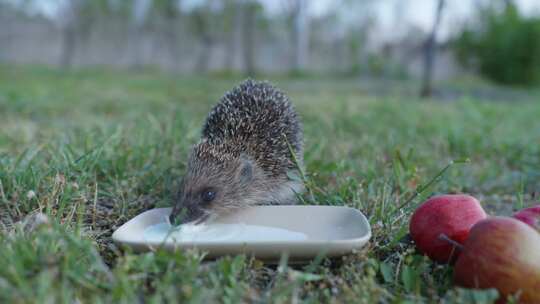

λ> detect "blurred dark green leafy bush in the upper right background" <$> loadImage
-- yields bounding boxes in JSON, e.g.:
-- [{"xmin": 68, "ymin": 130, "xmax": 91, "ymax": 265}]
[{"xmin": 454, "ymin": 1, "xmax": 540, "ymax": 85}]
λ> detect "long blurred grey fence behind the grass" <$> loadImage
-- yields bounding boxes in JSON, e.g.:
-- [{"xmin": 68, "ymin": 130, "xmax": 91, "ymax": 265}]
[{"xmin": 0, "ymin": 0, "xmax": 459, "ymax": 78}]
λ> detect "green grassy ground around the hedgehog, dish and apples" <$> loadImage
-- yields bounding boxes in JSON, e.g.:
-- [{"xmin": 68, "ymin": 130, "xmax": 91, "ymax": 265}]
[{"xmin": 0, "ymin": 66, "xmax": 540, "ymax": 303}]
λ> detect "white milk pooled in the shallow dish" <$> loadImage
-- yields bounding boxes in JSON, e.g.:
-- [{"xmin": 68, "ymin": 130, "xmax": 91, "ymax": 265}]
[{"xmin": 143, "ymin": 223, "xmax": 307, "ymax": 243}]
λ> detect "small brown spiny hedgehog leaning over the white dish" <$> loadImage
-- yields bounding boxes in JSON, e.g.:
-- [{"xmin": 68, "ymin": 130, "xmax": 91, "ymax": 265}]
[{"xmin": 169, "ymin": 79, "xmax": 304, "ymax": 224}]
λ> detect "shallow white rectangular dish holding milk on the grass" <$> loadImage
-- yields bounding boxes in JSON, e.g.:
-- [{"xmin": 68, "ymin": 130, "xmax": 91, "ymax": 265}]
[{"xmin": 112, "ymin": 206, "xmax": 371, "ymax": 261}]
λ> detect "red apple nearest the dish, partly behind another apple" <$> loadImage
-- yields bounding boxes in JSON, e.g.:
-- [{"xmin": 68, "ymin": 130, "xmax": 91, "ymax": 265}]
[{"xmin": 409, "ymin": 194, "xmax": 486, "ymax": 263}]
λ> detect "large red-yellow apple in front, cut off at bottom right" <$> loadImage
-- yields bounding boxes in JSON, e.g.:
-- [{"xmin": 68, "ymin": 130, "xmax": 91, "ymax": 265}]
[{"xmin": 454, "ymin": 217, "xmax": 540, "ymax": 304}]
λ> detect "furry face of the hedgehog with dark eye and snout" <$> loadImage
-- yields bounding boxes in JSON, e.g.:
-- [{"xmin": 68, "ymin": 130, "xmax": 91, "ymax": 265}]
[{"xmin": 170, "ymin": 147, "xmax": 258, "ymax": 225}]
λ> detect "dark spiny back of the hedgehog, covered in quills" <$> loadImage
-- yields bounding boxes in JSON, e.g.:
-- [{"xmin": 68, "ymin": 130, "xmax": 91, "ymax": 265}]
[{"xmin": 202, "ymin": 80, "xmax": 303, "ymax": 175}]
